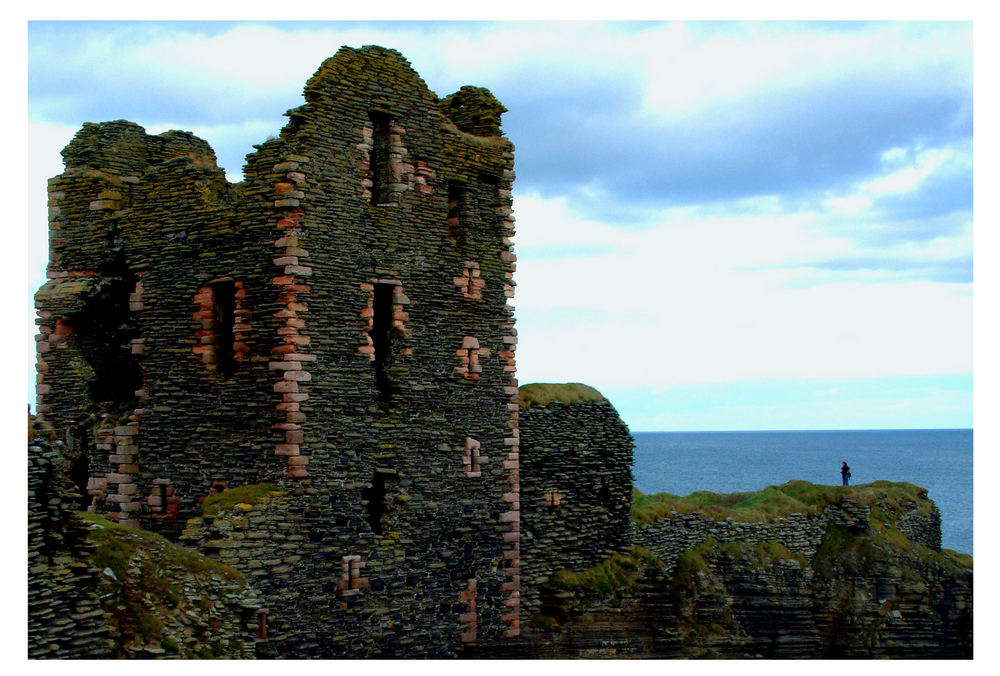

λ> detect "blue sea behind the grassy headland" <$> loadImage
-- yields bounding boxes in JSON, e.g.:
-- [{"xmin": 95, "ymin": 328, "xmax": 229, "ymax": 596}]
[{"xmin": 632, "ymin": 429, "xmax": 972, "ymax": 554}]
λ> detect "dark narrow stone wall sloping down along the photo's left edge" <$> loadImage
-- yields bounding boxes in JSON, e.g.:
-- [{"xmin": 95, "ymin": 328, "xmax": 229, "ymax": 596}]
[{"xmin": 28, "ymin": 418, "xmax": 111, "ymax": 659}]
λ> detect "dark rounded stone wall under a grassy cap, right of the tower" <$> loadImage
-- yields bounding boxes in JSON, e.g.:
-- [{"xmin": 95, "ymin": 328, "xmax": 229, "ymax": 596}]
[{"xmin": 519, "ymin": 390, "xmax": 633, "ymax": 614}]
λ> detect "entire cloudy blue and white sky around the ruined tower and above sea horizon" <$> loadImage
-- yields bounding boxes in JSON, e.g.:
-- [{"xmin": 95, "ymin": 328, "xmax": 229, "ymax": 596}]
[{"xmin": 28, "ymin": 21, "xmax": 973, "ymax": 431}]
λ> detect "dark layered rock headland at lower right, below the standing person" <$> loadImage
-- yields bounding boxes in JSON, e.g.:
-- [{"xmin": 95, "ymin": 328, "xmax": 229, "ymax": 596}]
[{"xmin": 521, "ymin": 482, "xmax": 973, "ymax": 659}]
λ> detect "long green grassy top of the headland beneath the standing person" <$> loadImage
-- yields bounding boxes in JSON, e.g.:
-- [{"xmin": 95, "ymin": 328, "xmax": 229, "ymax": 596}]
[{"xmin": 632, "ymin": 479, "xmax": 933, "ymax": 526}]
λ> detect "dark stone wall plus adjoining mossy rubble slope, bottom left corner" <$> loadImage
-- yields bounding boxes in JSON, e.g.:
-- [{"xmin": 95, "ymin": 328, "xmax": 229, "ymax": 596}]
[{"xmin": 28, "ymin": 420, "xmax": 260, "ymax": 659}]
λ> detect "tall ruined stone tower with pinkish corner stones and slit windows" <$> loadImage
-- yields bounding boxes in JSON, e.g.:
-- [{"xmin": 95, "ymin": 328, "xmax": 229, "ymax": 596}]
[{"xmin": 36, "ymin": 47, "xmax": 521, "ymax": 657}]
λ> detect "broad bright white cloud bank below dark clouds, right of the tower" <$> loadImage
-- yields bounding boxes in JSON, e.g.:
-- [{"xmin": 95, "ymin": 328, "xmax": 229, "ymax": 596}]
[{"xmin": 515, "ymin": 190, "xmax": 972, "ymax": 387}]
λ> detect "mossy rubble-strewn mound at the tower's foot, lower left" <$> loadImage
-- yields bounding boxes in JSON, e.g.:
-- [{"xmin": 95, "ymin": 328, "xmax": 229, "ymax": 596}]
[{"xmin": 81, "ymin": 513, "xmax": 256, "ymax": 658}]
